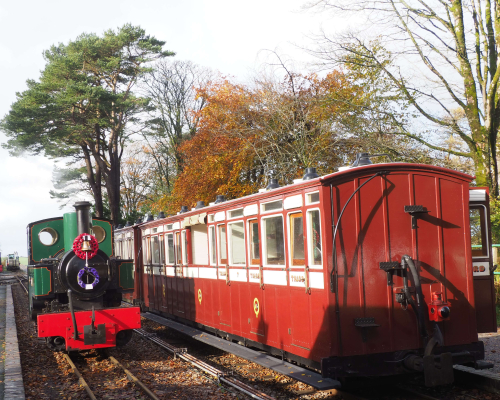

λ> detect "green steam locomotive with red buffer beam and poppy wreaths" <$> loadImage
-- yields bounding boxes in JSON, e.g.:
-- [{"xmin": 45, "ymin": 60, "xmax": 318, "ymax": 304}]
[{"xmin": 27, "ymin": 202, "xmax": 141, "ymax": 351}]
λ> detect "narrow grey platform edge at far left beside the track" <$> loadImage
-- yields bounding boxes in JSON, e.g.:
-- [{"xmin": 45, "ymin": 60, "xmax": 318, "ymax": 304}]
[{"xmin": 0, "ymin": 284, "xmax": 25, "ymax": 400}]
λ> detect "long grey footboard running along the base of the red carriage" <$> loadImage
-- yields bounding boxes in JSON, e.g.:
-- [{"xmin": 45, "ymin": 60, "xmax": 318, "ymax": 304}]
[{"xmin": 141, "ymin": 312, "xmax": 341, "ymax": 390}]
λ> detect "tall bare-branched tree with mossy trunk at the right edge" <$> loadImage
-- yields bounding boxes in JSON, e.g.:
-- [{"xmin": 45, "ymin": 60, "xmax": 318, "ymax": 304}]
[{"xmin": 309, "ymin": 0, "xmax": 500, "ymax": 196}]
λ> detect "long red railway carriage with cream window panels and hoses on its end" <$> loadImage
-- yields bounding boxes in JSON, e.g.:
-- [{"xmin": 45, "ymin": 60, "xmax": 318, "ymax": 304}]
[{"xmin": 116, "ymin": 163, "xmax": 496, "ymax": 385}]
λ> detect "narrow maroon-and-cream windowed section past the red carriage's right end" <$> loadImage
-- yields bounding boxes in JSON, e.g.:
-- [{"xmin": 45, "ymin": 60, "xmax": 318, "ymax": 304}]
[{"xmin": 469, "ymin": 188, "xmax": 497, "ymax": 333}]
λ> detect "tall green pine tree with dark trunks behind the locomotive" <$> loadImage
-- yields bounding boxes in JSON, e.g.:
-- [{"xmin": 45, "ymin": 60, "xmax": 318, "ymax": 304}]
[{"xmin": 1, "ymin": 24, "xmax": 173, "ymax": 221}]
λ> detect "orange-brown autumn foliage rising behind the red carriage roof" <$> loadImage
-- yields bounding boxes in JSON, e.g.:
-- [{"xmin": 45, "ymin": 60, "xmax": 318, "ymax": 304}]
[{"xmin": 156, "ymin": 71, "xmax": 362, "ymax": 213}]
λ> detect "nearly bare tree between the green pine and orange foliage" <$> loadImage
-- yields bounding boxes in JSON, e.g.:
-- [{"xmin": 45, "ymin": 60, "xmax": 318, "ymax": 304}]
[{"xmin": 142, "ymin": 59, "xmax": 214, "ymax": 194}]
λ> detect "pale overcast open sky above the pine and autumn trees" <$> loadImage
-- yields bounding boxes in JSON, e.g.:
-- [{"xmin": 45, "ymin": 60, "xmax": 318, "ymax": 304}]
[{"xmin": 0, "ymin": 0, "xmax": 345, "ymax": 256}]
